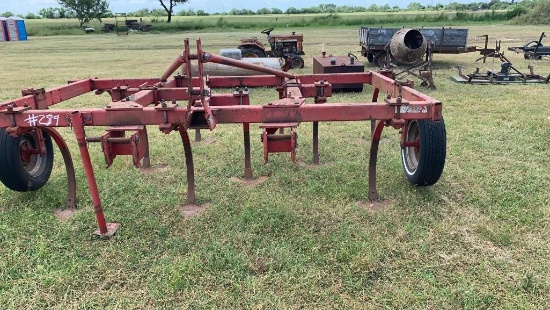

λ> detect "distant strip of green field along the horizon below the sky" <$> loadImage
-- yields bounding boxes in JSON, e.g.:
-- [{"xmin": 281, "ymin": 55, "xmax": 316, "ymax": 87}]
[{"xmin": 22, "ymin": 11, "xmax": 506, "ymax": 36}]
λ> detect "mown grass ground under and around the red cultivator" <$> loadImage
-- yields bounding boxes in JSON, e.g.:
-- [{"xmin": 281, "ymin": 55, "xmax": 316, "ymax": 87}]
[{"xmin": 0, "ymin": 25, "xmax": 550, "ymax": 309}]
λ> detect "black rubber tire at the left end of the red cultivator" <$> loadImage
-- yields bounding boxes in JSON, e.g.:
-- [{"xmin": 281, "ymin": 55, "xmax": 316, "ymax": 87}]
[{"xmin": 0, "ymin": 128, "xmax": 54, "ymax": 192}]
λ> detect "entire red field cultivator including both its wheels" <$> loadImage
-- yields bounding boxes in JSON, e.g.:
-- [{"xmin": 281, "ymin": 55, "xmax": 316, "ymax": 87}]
[{"xmin": 0, "ymin": 40, "xmax": 446, "ymax": 236}]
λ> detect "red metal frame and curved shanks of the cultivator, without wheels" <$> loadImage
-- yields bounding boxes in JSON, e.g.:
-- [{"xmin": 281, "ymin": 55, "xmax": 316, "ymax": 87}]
[{"xmin": 0, "ymin": 39, "xmax": 442, "ymax": 236}]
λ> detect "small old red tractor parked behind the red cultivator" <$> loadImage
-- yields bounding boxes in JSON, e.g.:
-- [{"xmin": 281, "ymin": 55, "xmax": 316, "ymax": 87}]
[{"xmin": 238, "ymin": 28, "xmax": 304, "ymax": 69}]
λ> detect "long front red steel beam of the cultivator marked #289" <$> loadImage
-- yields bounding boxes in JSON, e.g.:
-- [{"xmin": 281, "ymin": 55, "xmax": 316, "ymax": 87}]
[{"xmin": 0, "ymin": 98, "xmax": 441, "ymax": 128}]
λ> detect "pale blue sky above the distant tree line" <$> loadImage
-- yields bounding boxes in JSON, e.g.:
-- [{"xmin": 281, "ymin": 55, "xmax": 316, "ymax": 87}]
[{"xmin": 0, "ymin": 0, "xmax": 488, "ymax": 15}]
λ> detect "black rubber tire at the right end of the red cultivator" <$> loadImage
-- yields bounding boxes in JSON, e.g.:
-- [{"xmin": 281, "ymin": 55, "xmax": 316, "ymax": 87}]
[{"xmin": 401, "ymin": 119, "xmax": 447, "ymax": 186}]
